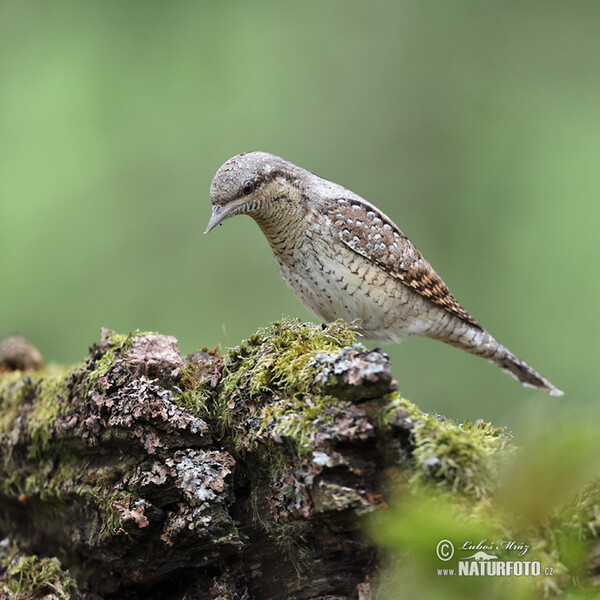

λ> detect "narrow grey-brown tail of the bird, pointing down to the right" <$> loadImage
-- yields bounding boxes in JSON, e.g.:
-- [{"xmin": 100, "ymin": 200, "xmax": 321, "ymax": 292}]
[{"xmin": 438, "ymin": 323, "xmax": 563, "ymax": 396}]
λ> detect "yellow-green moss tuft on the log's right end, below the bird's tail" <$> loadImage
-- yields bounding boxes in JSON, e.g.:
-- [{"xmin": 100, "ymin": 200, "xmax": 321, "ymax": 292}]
[{"xmin": 380, "ymin": 392, "xmax": 511, "ymax": 498}]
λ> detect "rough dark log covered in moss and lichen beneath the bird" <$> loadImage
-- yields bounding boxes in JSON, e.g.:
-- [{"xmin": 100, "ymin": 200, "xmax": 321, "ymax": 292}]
[{"xmin": 0, "ymin": 321, "xmax": 506, "ymax": 600}]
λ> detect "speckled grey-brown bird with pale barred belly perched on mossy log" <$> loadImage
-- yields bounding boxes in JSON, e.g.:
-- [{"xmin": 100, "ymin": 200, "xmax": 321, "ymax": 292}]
[{"xmin": 205, "ymin": 151, "xmax": 563, "ymax": 396}]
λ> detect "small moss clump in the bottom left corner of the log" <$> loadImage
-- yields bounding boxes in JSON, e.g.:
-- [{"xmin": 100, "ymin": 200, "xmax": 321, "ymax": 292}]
[{"xmin": 4, "ymin": 555, "xmax": 77, "ymax": 599}]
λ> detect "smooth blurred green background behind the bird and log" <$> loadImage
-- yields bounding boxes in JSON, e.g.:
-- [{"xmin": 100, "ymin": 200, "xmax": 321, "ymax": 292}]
[{"xmin": 0, "ymin": 0, "xmax": 600, "ymax": 428}]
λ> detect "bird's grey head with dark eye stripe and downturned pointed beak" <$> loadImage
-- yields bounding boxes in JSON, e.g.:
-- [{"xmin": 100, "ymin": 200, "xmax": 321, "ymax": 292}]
[{"xmin": 204, "ymin": 152, "xmax": 300, "ymax": 233}]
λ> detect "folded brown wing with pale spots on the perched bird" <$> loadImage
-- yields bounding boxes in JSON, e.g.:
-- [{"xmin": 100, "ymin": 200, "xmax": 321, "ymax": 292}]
[{"xmin": 323, "ymin": 197, "xmax": 482, "ymax": 329}]
